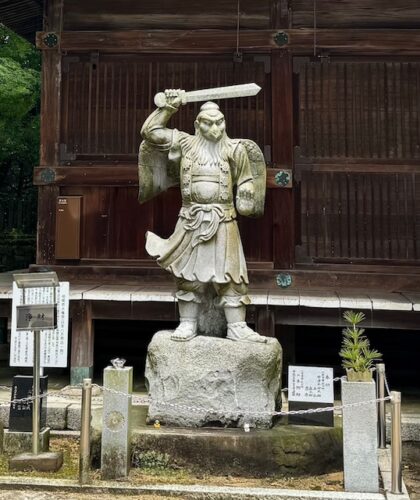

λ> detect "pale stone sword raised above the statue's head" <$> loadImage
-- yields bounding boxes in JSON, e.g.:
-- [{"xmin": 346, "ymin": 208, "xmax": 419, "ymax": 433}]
[{"xmin": 154, "ymin": 83, "xmax": 261, "ymax": 108}]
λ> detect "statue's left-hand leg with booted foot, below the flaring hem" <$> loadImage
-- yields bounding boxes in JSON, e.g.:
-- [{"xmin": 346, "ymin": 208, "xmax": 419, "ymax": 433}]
[{"xmin": 171, "ymin": 278, "xmax": 204, "ymax": 342}]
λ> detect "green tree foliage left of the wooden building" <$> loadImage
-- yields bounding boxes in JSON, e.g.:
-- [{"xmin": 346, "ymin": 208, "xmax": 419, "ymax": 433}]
[{"xmin": 0, "ymin": 24, "xmax": 41, "ymax": 268}]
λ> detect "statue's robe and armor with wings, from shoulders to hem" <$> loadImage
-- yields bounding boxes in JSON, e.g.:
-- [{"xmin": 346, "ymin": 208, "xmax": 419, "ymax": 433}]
[{"xmin": 139, "ymin": 130, "xmax": 265, "ymax": 284}]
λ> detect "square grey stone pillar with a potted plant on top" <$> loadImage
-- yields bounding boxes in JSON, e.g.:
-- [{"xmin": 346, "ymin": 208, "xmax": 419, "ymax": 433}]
[{"xmin": 341, "ymin": 380, "xmax": 379, "ymax": 493}]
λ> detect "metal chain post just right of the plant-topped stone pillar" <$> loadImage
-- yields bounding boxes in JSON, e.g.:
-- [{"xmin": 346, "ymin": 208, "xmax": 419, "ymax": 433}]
[{"xmin": 391, "ymin": 391, "xmax": 402, "ymax": 495}]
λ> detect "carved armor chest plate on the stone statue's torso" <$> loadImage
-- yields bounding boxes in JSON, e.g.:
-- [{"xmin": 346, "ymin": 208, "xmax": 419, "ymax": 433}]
[{"xmin": 181, "ymin": 154, "xmax": 233, "ymax": 204}]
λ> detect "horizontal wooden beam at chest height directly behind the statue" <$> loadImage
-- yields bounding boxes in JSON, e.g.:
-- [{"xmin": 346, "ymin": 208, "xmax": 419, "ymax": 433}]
[{"xmin": 34, "ymin": 165, "xmax": 288, "ymax": 189}]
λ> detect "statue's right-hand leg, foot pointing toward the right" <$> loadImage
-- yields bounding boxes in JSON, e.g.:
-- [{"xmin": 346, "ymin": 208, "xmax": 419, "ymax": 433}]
[{"xmin": 215, "ymin": 283, "xmax": 267, "ymax": 343}]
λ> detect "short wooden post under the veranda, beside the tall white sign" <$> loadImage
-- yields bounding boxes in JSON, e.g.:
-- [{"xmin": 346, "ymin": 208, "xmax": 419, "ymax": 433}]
[{"xmin": 70, "ymin": 300, "xmax": 95, "ymax": 385}]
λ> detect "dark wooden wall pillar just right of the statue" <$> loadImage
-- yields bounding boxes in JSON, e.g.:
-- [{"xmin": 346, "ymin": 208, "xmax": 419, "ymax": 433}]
[{"xmin": 272, "ymin": 50, "xmax": 295, "ymax": 269}]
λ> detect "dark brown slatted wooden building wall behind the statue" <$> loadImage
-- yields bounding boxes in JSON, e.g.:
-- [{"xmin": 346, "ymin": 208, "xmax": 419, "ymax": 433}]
[{"xmin": 35, "ymin": 0, "xmax": 420, "ymax": 286}]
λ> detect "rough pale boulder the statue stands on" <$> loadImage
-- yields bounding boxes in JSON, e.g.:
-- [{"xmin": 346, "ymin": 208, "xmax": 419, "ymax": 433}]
[{"xmin": 145, "ymin": 331, "xmax": 282, "ymax": 428}]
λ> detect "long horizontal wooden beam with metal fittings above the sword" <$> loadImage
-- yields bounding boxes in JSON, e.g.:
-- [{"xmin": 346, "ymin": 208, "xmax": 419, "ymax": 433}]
[{"xmin": 36, "ymin": 28, "xmax": 420, "ymax": 55}]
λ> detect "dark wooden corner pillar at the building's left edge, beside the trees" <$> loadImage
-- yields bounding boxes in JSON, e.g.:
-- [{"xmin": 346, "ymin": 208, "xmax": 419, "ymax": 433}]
[{"xmin": 36, "ymin": 0, "xmax": 63, "ymax": 264}]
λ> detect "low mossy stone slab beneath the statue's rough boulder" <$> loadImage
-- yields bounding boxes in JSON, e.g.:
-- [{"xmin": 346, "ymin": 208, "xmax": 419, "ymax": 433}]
[{"xmin": 107, "ymin": 406, "xmax": 343, "ymax": 477}]
